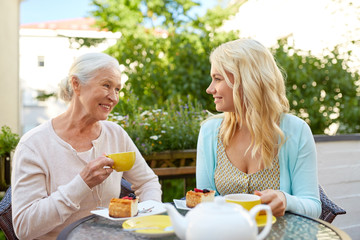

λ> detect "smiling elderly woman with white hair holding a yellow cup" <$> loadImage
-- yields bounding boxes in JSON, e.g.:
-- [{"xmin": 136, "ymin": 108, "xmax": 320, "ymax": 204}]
[{"xmin": 12, "ymin": 53, "xmax": 161, "ymax": 239}]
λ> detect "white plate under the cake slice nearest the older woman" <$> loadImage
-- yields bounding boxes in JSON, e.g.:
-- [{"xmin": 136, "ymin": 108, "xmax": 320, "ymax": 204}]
[{"xmin": 91, "ymin": 200, "xmax": 166, "ymax": 221}]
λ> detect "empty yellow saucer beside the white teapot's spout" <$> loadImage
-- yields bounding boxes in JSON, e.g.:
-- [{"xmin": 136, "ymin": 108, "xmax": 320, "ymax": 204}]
[{"xmin": 122, "ymin": 215, "xmax": 174, "ymax": 238}]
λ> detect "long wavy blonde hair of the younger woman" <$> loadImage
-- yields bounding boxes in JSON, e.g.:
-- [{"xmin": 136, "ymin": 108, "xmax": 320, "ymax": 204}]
[{"xmin": 210, "ymin": 39, "xmax": 289, "ymax": 168}]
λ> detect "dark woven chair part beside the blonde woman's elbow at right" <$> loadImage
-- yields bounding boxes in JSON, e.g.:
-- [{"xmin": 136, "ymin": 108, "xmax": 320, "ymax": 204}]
[{"xmin": 319, "ymin": 184, "xmax": 346, "ymax": 223}]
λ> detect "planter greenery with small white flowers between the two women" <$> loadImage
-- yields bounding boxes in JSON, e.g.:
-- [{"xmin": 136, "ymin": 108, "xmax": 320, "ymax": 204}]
[{"xmin": 109, "ymin": 94, "xmax": 209, "ymax": 155}]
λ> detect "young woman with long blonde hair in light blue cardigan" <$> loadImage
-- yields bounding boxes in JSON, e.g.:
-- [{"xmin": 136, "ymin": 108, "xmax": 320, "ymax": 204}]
[{"xmin": 196, "ymin": 39, "xmax": 321, "ymax": 217}]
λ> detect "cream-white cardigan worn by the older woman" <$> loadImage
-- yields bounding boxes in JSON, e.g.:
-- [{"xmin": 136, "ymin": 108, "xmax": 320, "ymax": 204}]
[{"xmin": 11, "ymin": 120, "xmax": 161, "ymax": 239}]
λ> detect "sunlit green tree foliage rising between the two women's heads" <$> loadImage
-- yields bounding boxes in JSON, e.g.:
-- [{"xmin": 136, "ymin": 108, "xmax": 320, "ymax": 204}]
[{"xmin": 93, "ymin": 0, "xmax": 239, "ymax": 108}]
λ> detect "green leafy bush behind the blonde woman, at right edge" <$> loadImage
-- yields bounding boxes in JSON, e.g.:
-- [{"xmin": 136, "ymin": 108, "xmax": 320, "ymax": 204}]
[{"xmin": 274, "ymin": 39, "xmax": 360, "ymax": 134}]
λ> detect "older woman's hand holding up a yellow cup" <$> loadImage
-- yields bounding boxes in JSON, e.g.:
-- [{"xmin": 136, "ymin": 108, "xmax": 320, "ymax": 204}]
[{"xmin": 80, "ymin": 154, "xmax": 114, "ymax": 188}]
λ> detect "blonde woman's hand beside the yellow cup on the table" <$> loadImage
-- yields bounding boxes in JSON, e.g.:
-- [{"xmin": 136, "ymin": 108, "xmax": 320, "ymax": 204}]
[{"xmin": 254, "ymin": 189, "xmax": 286, "ymax": 217}]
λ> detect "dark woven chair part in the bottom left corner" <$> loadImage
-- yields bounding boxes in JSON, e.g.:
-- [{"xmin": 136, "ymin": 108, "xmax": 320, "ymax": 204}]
[{"xmin": 0, "ymin": 186, "xmax": 18, "ymax": 240}]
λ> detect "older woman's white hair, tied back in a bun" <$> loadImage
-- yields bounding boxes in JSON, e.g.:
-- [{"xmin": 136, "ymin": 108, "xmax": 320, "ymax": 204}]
[{"xmin": 59, "ymin": 53, "xmax": 121, "ymax": 102}]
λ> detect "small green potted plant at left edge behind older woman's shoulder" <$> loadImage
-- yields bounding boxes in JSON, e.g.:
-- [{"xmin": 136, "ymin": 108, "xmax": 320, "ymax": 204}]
[{"xmin": 0, "ymin": 125, "xmax": 20, "ymax": 189}]
